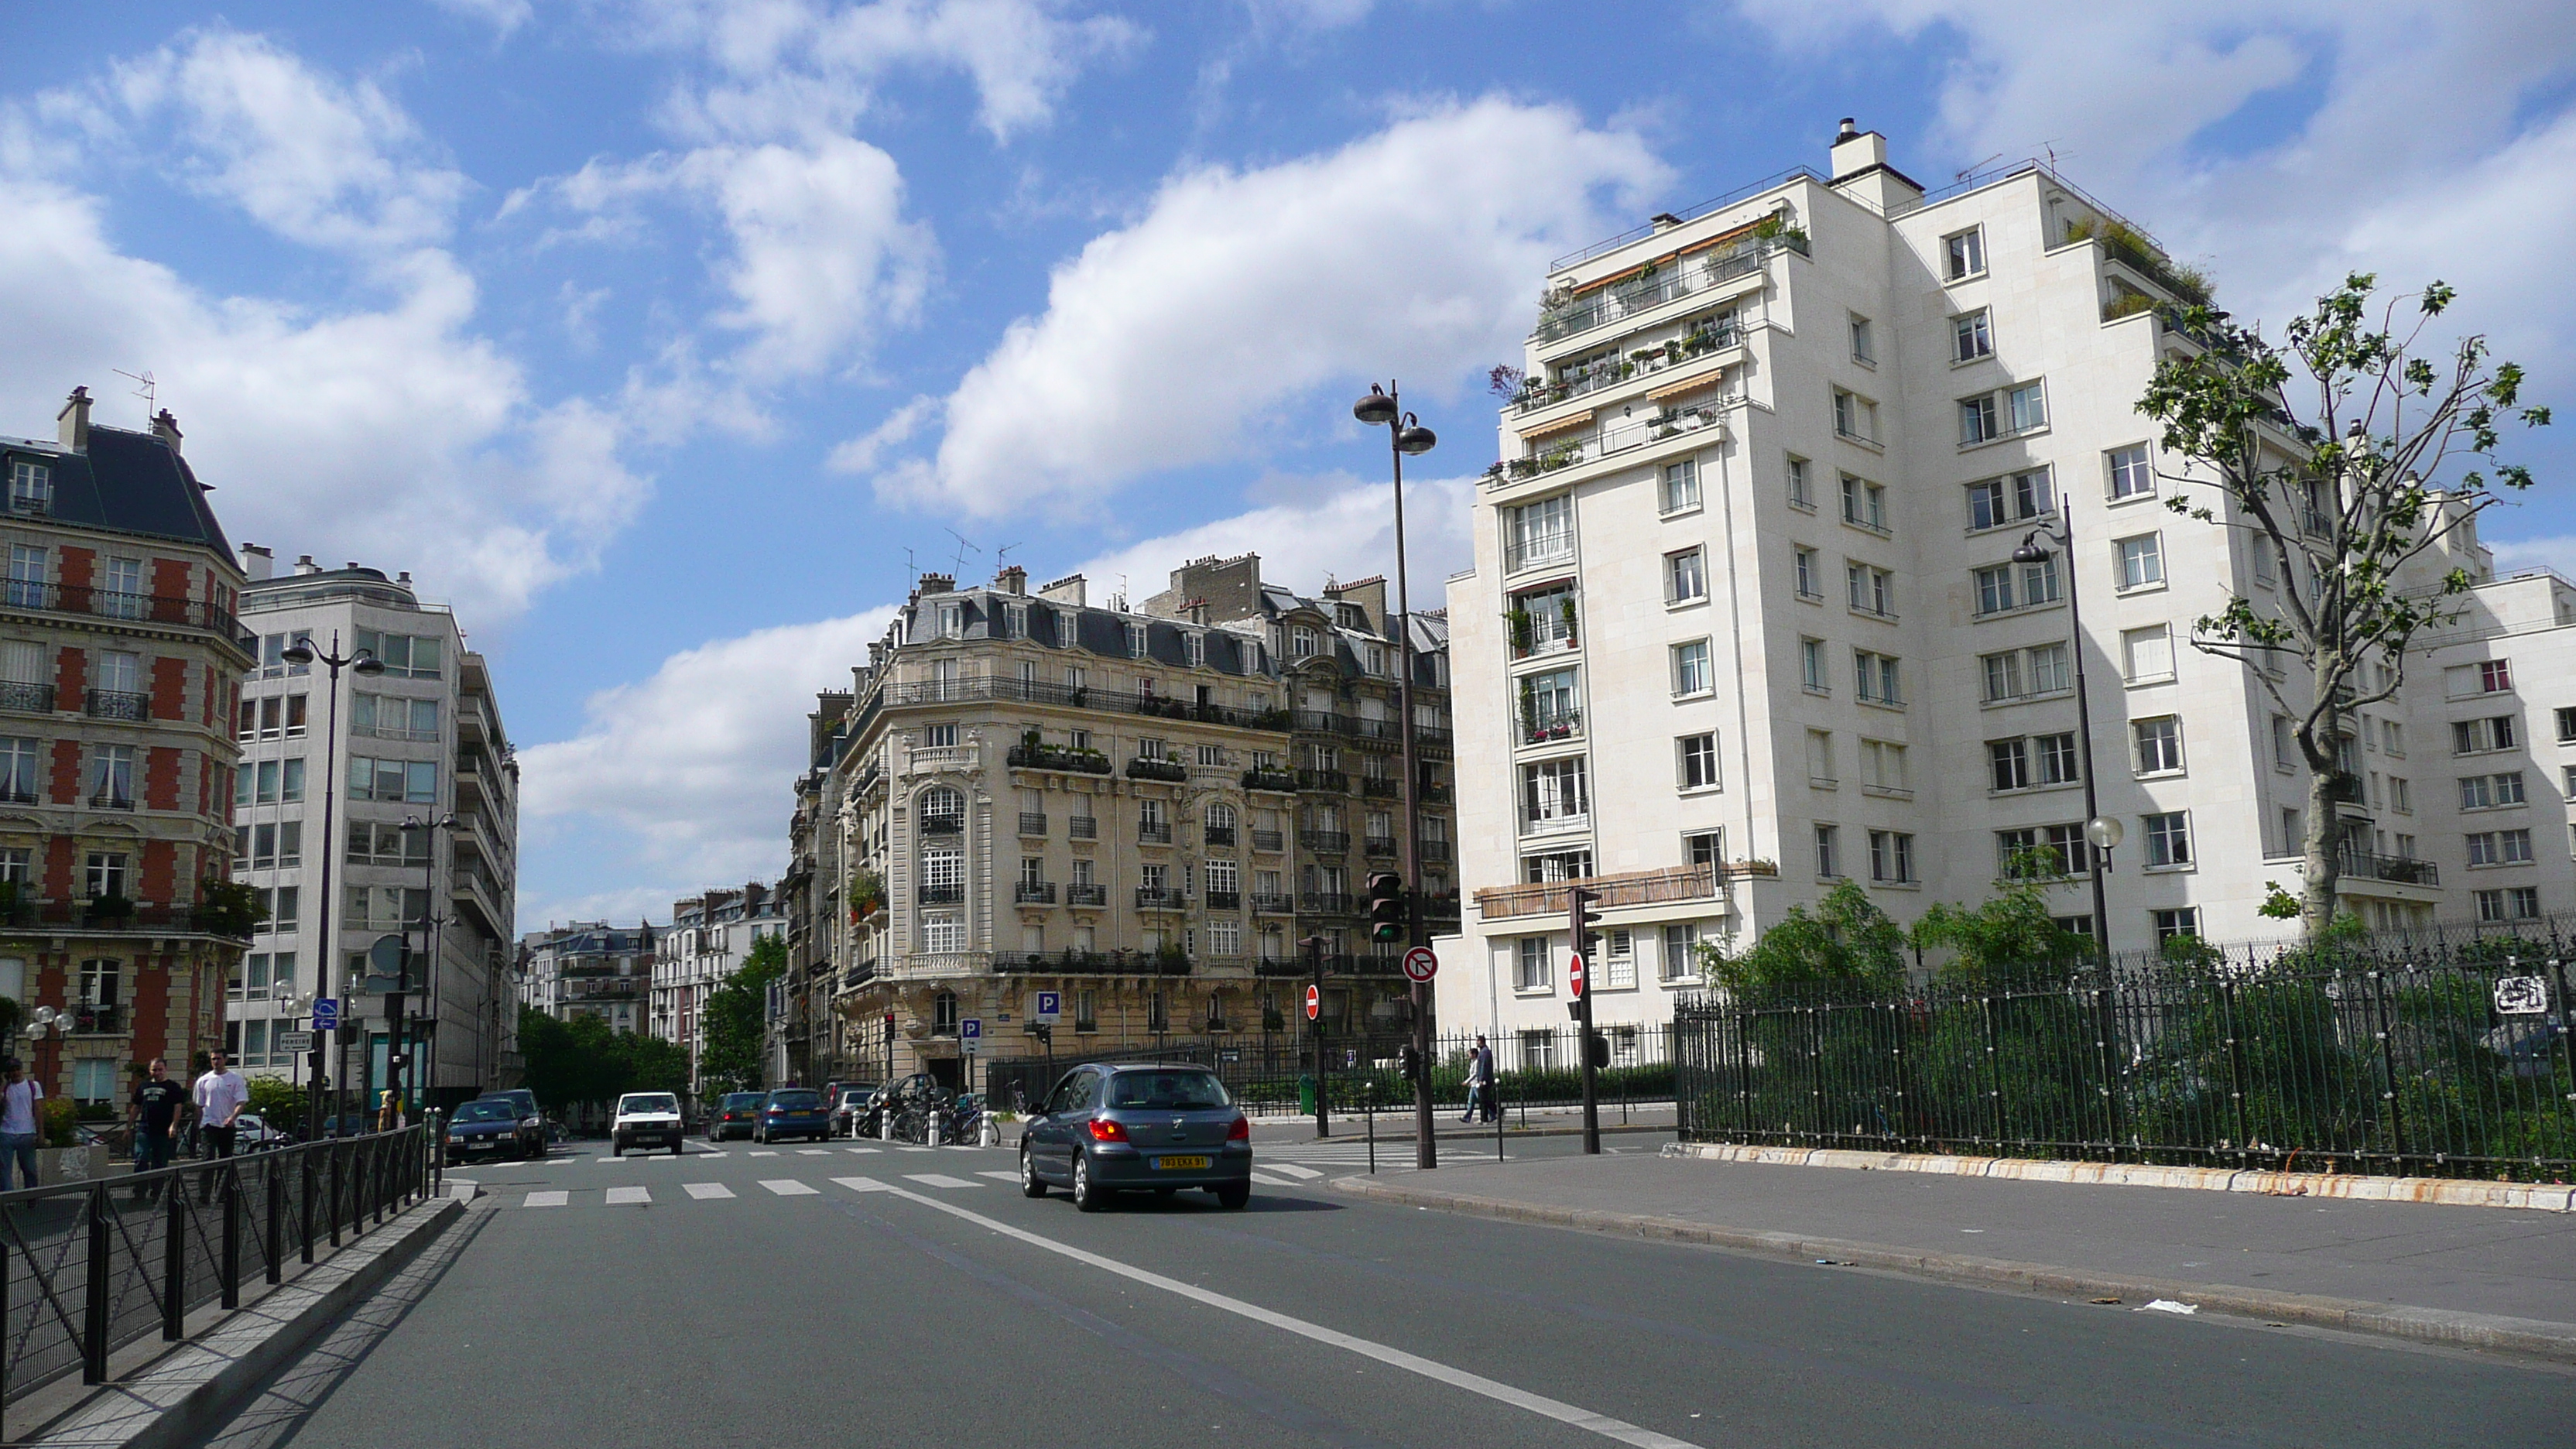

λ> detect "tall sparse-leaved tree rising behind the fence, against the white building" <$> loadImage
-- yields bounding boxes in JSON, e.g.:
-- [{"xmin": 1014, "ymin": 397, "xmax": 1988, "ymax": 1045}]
[{"xmin": 2138, "ymin": 273, "xmax": 2550, "ymax": 936}]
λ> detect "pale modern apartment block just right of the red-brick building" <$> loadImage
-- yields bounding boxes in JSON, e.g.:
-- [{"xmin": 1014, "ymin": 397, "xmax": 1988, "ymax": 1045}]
[{"xmin": 224, "ymin": 544, "xmax": 518, "ymax": 1096}]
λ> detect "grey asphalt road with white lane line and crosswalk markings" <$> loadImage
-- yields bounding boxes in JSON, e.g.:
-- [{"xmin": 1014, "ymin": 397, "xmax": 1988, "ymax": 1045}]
[{"xmin": 187, "ymin": 1137, "xmax": 2576, "ymax": 1449}]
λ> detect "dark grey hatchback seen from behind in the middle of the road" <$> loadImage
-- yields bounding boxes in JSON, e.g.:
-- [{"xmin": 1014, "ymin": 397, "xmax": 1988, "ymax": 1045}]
[{"xmin": 1020, "ymin": 1065, "xmax": 1252, "ymax": 1212}]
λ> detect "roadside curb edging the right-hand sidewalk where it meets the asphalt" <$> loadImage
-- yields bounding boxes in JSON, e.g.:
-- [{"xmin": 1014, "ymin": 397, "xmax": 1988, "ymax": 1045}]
[{"xmin": 1332, "ymin": 1178, "xmax": 2576, "ymax": 1364}]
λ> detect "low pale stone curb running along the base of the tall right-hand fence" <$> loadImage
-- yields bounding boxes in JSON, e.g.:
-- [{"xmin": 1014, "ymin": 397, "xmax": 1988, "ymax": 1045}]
[{"xmin": 1664, "ymin": 1142, "xmax": 2576, "ymax": 1212}]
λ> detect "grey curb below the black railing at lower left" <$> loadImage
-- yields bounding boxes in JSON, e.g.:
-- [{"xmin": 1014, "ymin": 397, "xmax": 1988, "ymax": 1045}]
[{"xmin": 29, "ymin": 1199, "xmax": 464, "ymax": 1449}]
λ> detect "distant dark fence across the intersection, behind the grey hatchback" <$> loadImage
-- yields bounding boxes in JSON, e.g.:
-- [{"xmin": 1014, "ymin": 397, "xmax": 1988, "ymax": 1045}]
[{"xmin": 976, "ymin": 1023, "xmax": 1672, "ymax": 1116}]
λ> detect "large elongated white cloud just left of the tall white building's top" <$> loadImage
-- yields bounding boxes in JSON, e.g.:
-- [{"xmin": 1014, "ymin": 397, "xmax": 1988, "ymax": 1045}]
[{"xmin": 879, "ymin": 98, "xmax": 1667, "ymax": 516}]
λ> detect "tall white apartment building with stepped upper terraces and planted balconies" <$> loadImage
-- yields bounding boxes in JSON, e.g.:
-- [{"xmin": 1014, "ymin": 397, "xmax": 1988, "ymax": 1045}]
[{"xmin": 1437, "ymin": 122, "xmax": 2576, "ymax": 1031}]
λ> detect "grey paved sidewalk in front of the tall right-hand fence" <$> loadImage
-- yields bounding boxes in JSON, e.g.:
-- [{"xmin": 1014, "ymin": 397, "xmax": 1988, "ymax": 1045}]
[{"xmin": 1334, "ymin": 1153, "xmax": 2576, "ymax": 1362}]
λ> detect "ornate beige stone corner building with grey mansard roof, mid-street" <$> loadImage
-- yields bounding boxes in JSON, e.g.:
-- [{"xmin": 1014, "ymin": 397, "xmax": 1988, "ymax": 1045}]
[{"xmin": 772, "ymin": 554, "xmax": 1458, "ymax": 1081}]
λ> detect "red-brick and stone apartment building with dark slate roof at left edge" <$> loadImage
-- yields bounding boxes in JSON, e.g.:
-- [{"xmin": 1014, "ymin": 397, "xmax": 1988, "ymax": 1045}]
[{"xmin": 0, "ymin": 389, "xmax": 252, "ymax": 1112}]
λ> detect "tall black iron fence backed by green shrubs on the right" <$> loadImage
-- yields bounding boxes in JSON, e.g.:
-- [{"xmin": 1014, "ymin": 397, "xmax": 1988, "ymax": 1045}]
[{"xmin": 1674, "ymin": 920, "xmax": 2576, "ymax": 1181}]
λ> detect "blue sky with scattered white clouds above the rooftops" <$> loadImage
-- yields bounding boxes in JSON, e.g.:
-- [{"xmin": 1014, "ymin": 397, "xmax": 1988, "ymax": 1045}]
[{"xmin": 0, "ymin": 0, "xmax": 2576, "ymax": 928}]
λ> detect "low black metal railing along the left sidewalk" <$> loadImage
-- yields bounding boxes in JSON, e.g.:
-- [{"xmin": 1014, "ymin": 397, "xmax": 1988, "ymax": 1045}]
[{"xmin": 0, "ymin": 1127, "xmax": 438, "ymax": 1405}]
